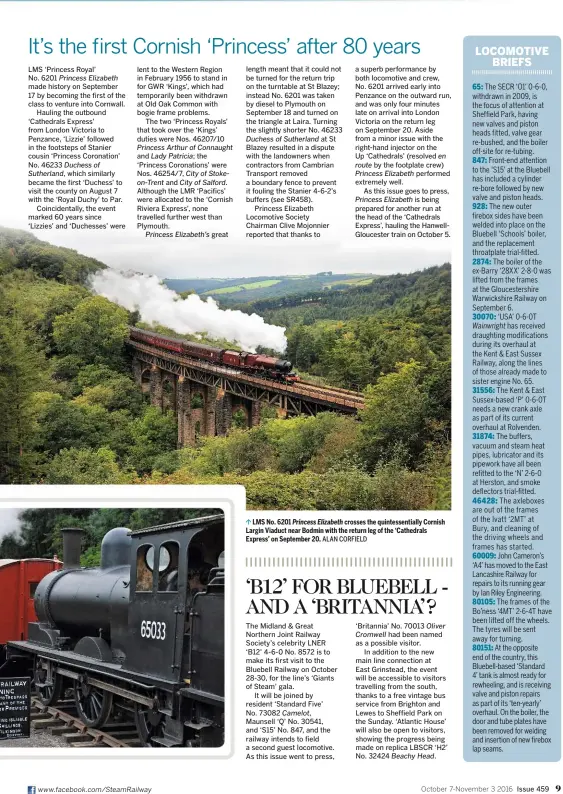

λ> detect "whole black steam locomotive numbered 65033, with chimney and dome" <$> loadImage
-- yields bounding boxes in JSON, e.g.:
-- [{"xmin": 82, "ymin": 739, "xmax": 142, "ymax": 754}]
[{"xmin": 0, "ymin": 514, "xmax": 225, "ymax": 747}]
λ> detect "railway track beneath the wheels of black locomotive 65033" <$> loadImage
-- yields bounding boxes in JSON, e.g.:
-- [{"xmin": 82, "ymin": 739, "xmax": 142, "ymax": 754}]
[{"xmin": 31, "ymin": 697, "xmax": 142, "ymax": 748}]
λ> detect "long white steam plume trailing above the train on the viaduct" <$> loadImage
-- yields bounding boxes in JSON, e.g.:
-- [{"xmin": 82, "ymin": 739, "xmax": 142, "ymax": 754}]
[{"xmin": 91, "ymin": 268, "xmax": 287, "ymax": 353}]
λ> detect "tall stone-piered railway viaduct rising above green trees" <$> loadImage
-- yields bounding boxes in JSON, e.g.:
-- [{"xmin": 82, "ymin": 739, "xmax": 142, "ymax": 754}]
[{"xmin": 127, "ymin": 339, "xmax": 364, "ymax": 447}]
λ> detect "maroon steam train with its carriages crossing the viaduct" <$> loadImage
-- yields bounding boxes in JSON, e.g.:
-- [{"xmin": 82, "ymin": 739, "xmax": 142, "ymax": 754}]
[{"xmin": 129, "ymin": 327, "xmax": 299, "ymax": 383}]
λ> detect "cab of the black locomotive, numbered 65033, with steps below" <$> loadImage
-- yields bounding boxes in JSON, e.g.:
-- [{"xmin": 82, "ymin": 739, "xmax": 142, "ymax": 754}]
[{"xmin": 127, "ymin": 515, "xmax": 225, "ymax": 746}]
